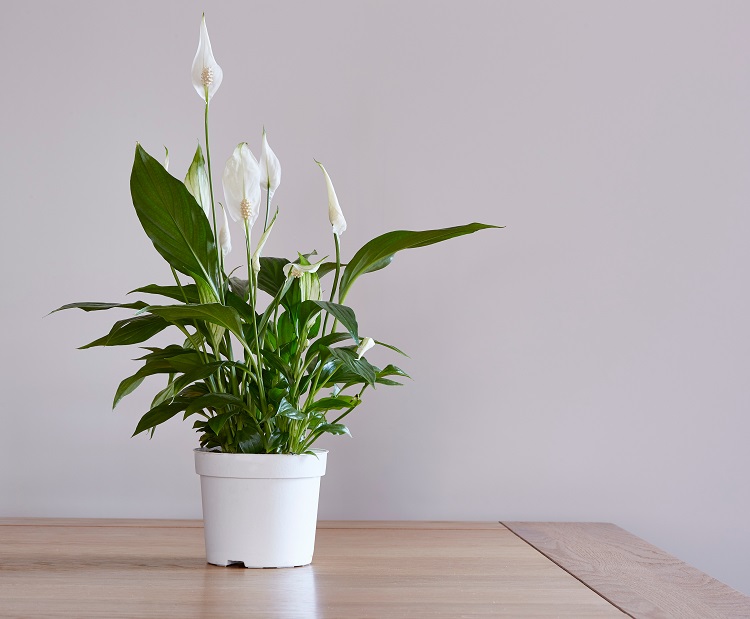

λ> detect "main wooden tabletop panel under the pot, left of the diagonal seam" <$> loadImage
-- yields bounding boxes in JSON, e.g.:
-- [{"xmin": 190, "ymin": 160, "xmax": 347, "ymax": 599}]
[{"xmin": 0, "ymin": 520, "xmax": 623, "ymax": 619}]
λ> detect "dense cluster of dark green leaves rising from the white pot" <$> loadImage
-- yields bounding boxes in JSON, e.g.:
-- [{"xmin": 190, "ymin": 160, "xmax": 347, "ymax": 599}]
[{"xmin": 55, "ymin": 145, "xmax": 494, "ymax": 453}]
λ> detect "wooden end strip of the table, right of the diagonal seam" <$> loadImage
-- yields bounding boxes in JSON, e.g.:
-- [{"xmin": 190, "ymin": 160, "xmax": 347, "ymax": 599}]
[{"xmin": 503, "ymin": 522, "xmax": 750, "ymax": 619}]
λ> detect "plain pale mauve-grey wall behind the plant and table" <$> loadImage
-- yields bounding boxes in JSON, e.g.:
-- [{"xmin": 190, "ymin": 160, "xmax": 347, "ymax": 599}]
[{"xmin": 0, "ymin": 0, "xmax": 750, "ymax": 593}]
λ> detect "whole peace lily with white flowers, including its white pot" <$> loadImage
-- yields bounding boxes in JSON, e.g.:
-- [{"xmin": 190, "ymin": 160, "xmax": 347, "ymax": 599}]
[{"xmin": 55, "ymin": 18, "xmax": 496, "ymax": 567}]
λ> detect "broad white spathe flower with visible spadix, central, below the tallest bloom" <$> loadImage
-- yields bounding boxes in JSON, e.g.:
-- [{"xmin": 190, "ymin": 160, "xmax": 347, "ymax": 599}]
[{"xmin": 222, "ymin": 142, "xmax": 260, "ymax": 228}]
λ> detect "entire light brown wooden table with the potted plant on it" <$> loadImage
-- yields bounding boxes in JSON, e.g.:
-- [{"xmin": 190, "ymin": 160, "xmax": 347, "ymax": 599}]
[{"xmin": 0, "ymin": 518, "xmax": 750, "ymax": 619}]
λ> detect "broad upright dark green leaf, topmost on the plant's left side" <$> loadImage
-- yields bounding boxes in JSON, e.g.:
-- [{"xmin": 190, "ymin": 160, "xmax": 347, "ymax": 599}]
[{"xmin": 130, "ymin": 144, "xmax": 220, "ymax": 298}]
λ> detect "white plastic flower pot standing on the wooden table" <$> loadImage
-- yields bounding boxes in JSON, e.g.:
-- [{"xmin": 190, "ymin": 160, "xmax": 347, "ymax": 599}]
[{"xmin": 194, "ymin": 449, "xmax": 328, "ymax": 567}]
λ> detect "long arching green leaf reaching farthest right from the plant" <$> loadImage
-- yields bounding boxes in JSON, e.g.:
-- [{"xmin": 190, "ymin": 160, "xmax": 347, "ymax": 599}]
[{"xmin": 339, "ymin": 223, "xmax": 502, "ymax": 303}]
